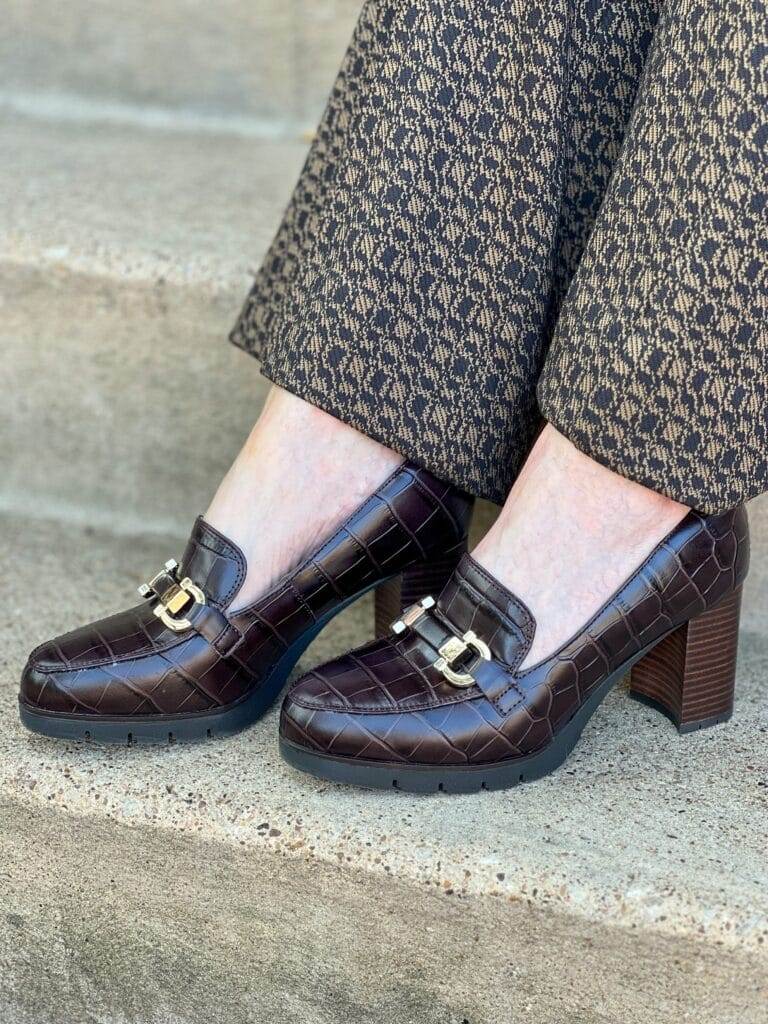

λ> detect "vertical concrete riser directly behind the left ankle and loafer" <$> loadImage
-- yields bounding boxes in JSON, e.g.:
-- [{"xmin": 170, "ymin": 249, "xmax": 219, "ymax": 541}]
[{"xmin": 0, "ymin": 260, "xmax": 268, "ymax": 534}]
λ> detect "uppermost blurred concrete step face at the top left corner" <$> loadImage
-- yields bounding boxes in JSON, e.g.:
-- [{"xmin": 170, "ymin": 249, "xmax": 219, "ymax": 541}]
[{"xmin": 0, "ymin": 0, "xmax": 360, "ymax": 133}]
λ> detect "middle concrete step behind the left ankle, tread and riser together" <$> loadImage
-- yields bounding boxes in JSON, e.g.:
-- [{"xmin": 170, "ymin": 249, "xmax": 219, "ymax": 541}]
[{"xmin": 0, "ymin": 117, "xmax": 306, "ymax": 531}]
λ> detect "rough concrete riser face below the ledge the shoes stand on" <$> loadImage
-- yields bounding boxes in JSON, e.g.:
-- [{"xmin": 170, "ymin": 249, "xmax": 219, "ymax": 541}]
[{"xmin": 0, "ymin": 795, "xmax": 765, "ymax": 1024}]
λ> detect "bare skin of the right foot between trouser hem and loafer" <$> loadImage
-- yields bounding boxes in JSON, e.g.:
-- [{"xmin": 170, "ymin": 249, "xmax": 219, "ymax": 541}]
[{"xmin": 473, "ymin": 425, "xmax": 688, "ymax": 669}]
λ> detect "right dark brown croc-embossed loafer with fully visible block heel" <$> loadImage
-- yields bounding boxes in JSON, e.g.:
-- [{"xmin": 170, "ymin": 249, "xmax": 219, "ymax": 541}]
[{"xmin": 281, "ymin": 508, "xmax": 750, "ymax": 793}]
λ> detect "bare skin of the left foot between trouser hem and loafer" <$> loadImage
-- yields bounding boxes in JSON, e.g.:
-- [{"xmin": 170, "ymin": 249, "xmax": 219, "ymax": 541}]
[{"xmin": 205, "ymin": 387, "xmax": 403, "ymax": 609}]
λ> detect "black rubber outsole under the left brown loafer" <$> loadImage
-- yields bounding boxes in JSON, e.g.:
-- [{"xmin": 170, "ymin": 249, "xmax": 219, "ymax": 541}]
[{"xmin": 18, "ymin": 581, "xmax": 388, "ymax": 746}]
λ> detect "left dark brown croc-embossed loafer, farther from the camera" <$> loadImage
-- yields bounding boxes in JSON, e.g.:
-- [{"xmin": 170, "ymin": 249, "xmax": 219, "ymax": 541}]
[{"xmin": 19, "ymin": 464, "xmax": 471, "ymax": 742}]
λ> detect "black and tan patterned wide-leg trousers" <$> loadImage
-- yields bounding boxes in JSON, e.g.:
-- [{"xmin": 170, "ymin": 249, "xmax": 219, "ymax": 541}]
[{"xmin": 232, "ymin": 0, "xmax": 768, "ymax": 512}]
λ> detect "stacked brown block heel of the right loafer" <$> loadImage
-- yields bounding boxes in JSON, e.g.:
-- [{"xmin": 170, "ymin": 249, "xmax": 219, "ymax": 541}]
[{"xmin": 630, "ymin": 588, "xmax": 741, "ymax": 733}]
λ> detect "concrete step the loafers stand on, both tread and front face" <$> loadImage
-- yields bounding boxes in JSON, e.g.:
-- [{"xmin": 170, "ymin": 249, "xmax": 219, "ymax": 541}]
[{"xmin": 0, "ymin": 516, "xmax": 768, "ymax": 1024}]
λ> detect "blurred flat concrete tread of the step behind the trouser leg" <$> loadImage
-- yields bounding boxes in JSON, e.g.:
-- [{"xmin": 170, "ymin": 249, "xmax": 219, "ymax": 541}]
[{"xmin": 0, "ymin": 116, "xmax": 307, "ymax": 292}]
